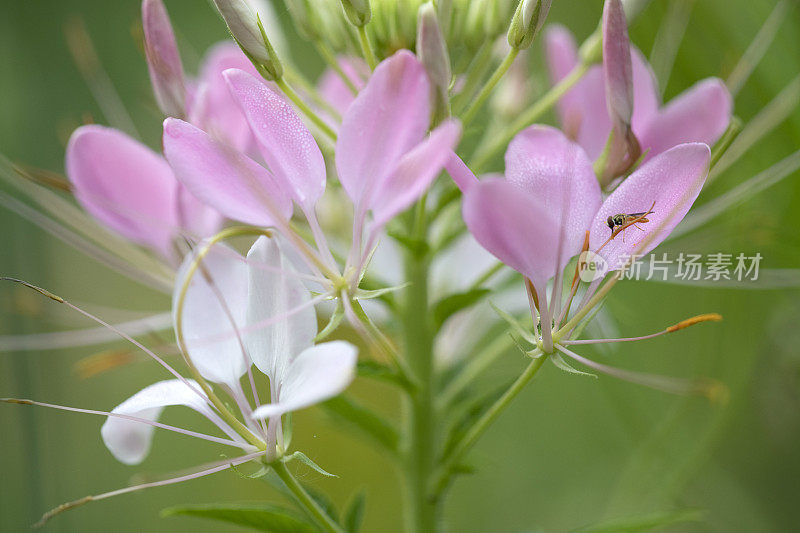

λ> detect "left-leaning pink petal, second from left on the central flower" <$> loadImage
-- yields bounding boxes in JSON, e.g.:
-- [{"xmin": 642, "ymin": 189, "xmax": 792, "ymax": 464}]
[{"xmin": 223, "ymin": 69, "xmax": 326, "ymax": 209}]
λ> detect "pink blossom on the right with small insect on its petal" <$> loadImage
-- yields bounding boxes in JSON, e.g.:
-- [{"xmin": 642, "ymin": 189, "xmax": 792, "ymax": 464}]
[{"xmin": 460, "ymin": 126, "xmax": 719, "ymax": 392}]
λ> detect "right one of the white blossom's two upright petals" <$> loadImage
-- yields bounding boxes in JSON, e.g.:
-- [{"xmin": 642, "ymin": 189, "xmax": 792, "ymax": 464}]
[{"xmin": 246, "ymin": 237, "xmax": 317, "ymax": 383}]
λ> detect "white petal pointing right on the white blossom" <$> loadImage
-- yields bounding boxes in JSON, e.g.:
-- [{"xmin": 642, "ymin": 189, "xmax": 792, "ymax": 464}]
[{"xmin": 253, "ymin": 341, "xmax": 358, "ymax": 418}]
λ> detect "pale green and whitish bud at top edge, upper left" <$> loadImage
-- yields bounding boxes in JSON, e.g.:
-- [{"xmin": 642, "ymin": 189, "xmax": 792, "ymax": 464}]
[{"xmin": 214, "ymin": 0, "xmax": 283, "ymax": 80}]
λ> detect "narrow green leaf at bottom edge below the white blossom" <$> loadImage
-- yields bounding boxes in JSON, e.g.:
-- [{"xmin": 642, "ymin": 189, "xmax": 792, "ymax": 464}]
[{"xmin": 161, "ymin": 503, "xmax": 319, "ymax": 533}]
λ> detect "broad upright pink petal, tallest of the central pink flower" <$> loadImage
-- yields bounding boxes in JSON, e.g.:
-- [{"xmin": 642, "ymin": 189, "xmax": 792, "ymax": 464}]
[{"xmin": 336, "ymin": 50, "xmax": 430, "ymax": 207}]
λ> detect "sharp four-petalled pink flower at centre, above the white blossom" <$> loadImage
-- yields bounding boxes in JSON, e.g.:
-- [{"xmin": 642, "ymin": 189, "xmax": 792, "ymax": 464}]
[{"xmin": 164, "ymin": 51, "xmax": 460, "ymax": 281}]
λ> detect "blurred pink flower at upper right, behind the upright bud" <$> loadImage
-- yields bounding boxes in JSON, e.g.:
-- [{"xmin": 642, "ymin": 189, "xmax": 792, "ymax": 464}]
[{"xmin": 545, "ymin": 22, "xmax": 733, "ymax": 160}]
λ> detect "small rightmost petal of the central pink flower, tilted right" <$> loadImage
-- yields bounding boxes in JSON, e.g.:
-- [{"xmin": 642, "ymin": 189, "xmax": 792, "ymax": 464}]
[{"xmin": 369, "ymin": 120, "xmax": 461, "ymax": 226}]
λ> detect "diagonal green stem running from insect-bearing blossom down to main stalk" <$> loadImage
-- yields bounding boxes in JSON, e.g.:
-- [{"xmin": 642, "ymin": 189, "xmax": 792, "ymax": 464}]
[{"xmin": 433, "ymin": 350, "xmax": 547, "ymax": 494}]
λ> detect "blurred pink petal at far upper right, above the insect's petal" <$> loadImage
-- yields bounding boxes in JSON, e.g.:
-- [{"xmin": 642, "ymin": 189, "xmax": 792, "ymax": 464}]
[{"xmin": 640, "ymin": 78, "xmax": 733, "ymax": 158}]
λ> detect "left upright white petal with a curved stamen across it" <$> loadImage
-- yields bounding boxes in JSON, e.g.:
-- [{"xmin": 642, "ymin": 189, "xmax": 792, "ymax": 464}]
[{"xmin": 172, "ymin": 245, "xmax": 247, "ymax": 388}]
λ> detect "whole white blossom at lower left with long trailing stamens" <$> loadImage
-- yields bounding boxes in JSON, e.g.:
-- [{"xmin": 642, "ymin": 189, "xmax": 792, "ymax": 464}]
[{"xmin": 3, "ymin": 237, "xmax": 357, "ymax": 521}]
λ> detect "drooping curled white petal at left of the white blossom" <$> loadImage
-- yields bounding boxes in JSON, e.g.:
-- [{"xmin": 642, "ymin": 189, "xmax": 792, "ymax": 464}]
[{"xmin": 100, "ymin": 379, "xmax": 222, "ymax": 465}]
